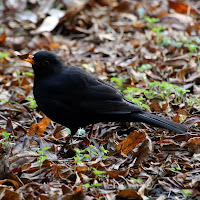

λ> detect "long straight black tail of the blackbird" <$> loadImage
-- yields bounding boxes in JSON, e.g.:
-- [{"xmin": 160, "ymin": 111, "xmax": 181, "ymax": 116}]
[{"xmin": 133, "ymin": 112, "xmax": 188, "ymax": 133}]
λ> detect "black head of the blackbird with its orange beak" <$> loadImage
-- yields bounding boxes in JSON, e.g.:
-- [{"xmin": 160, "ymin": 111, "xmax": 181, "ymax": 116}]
[{"xmin": 24, "ymin": 51, "xmax": 63, "ymax": 77}]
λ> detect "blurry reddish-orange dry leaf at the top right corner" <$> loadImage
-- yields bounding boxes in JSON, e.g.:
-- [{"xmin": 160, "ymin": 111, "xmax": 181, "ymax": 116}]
[{"xmin": 168, "ymin": 1, "xmax": 199, "ymax": 15}]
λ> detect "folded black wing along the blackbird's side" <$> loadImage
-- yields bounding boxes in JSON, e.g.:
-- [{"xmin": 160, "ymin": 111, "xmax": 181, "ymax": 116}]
[{"xmin": 45, "ymin": 67, "xmax": 143, "ymax": 114}]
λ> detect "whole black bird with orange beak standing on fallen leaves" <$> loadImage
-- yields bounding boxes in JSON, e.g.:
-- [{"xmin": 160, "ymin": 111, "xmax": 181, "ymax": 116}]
[{"xmin": 23, "ymin": 51, "xmax": 187, "ymax": 134}]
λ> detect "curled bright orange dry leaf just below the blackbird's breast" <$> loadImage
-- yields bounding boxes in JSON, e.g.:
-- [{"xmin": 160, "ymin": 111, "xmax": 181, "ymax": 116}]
[{"xmin": 27, "ymin": 117, "xmax": 51, "ymax": 136}]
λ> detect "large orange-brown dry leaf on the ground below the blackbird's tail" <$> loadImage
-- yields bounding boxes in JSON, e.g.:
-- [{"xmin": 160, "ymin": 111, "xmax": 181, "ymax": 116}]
[{"xmin": 116, "ymin": 130, "xmax": 146, "ymax": 155}]
